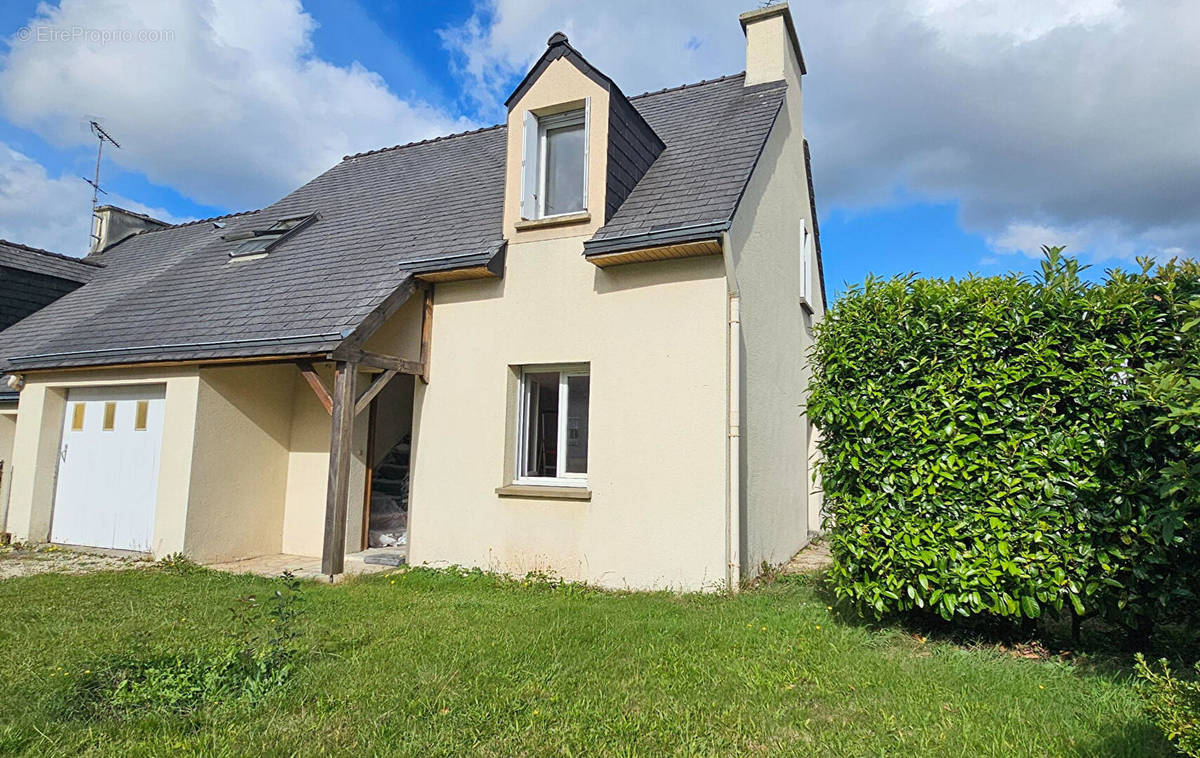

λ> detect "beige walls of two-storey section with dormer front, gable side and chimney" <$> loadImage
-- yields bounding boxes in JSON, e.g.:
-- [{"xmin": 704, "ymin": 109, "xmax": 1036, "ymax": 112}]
[{"xmin": 410, "ymin": 4, "xmax": 823, "ymax": 590}]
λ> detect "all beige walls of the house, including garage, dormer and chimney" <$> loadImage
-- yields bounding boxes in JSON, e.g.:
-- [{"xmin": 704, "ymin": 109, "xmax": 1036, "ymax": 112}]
[{"xmin": 0, "ymin": 2, "xmax": 824, "ymax": 590}]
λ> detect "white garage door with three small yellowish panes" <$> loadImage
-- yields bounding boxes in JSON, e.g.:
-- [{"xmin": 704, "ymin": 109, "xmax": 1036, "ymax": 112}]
[{"xmin": 50, "ymin": 385, "xmax": 166, "ymax": 552}]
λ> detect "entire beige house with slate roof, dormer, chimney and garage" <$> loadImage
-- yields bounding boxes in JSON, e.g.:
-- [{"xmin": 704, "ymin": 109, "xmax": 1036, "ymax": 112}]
[{"xmin": 0, "ymin": 5, "xmax": 824, "ymax": 589}]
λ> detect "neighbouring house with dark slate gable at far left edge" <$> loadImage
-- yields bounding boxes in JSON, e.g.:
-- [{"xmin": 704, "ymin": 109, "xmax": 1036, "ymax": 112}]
[{"xmin": 0, "ymin": 240, "xmax": 97, "ymax": 533}]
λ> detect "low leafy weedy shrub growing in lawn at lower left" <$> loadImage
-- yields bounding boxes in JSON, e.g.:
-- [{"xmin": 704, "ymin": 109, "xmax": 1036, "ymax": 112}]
[{"xmin": 72, "ymin": 564, "xmax": 304, "ymax": 716}]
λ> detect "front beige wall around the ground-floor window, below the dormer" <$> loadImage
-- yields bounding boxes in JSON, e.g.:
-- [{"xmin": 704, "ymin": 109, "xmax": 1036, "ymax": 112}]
[{"xmin": 409, "ymin": 236, "xmax": 726, "ymax": 589}]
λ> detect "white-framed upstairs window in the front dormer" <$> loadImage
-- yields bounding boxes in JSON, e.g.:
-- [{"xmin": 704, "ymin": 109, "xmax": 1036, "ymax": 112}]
[{"xmin": 521, "ymin": 102, "xmax": 589, "ymax": 218}]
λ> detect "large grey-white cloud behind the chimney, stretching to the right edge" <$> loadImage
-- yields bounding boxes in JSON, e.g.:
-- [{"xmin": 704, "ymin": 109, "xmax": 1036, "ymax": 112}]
[{"xmin": 443, "ymin": 0, "xmax": 1200, "ymax": 259}]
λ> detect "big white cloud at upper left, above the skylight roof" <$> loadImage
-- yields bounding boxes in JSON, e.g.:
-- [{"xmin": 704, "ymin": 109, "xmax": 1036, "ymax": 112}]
[{"xmin": 0, "ymin": 0, "xmax": 473, "ymax": 207}]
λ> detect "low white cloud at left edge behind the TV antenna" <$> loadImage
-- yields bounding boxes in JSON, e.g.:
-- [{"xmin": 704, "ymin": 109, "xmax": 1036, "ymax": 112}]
[{"xmin": 0, "ymin": 143, "xmax": 186, "ymax": 255}]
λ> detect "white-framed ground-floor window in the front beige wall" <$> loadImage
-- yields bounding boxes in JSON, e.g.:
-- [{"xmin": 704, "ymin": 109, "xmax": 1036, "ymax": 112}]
[{"xmin": 515, "ymin": 363, "xmax": 592, "ymax": 487}]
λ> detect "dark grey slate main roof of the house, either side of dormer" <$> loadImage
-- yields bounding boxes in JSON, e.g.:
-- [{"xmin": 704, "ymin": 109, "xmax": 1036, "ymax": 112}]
[{"xmin": 0, "ymin": 74, "xmax": 786, "ymax": 371}]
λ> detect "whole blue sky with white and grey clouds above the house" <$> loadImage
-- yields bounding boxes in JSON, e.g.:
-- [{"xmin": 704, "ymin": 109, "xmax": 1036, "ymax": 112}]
[{"xmin": 0, "ymin": 0, "xmax": 1200, "ymax": 301}]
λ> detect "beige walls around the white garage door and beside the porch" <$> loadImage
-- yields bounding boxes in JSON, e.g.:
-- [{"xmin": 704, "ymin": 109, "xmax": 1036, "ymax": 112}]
[{"xmin": 8, "ymin": 362, "xmax": 368, "ymax": 561}]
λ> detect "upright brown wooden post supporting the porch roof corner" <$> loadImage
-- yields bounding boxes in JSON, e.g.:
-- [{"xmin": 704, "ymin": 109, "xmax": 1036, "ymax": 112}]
[{"xmin": 320, "ymin": 361, "xmax": 358, "ymax": 578}]
